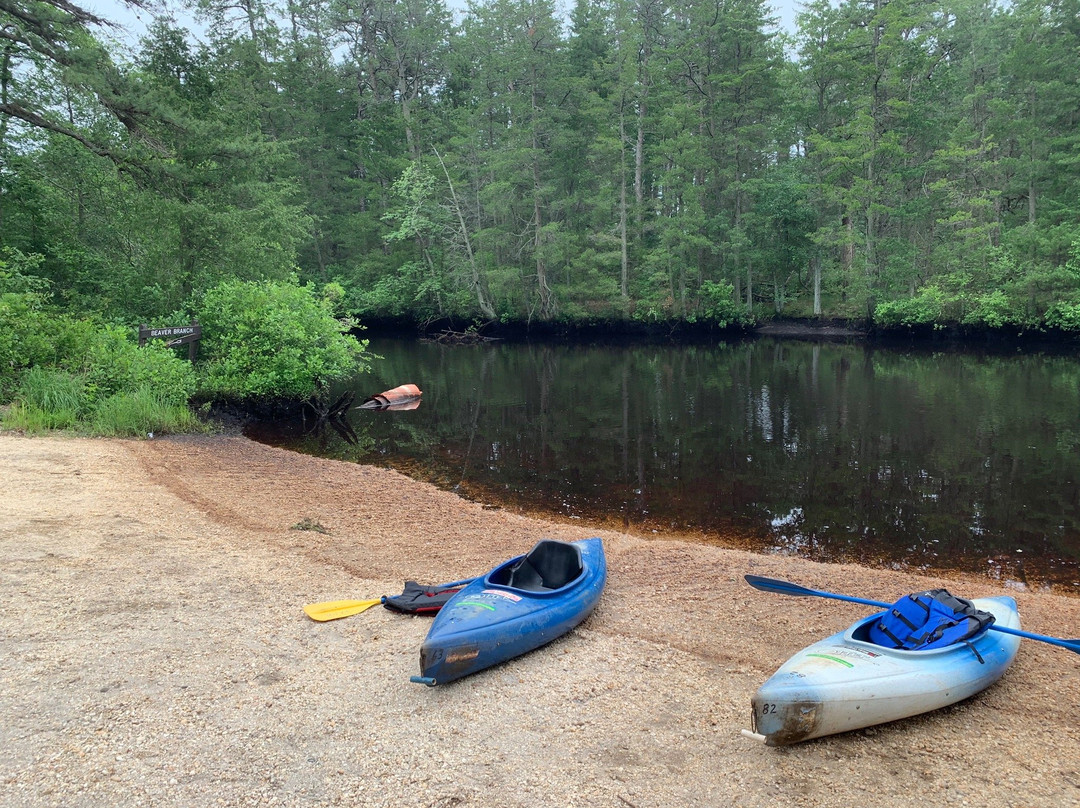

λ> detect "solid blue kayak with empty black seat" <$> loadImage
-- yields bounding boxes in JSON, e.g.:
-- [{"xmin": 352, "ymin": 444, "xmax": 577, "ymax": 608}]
[{"xmin": 413, "ymin": 538, "xmax": 607, "ymax": 686}]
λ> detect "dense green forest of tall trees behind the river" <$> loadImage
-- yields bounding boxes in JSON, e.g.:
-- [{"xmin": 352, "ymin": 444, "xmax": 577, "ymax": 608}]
[{"xmin": 0, "ymin": 0, "xmax": 1080, "ymax": 332}]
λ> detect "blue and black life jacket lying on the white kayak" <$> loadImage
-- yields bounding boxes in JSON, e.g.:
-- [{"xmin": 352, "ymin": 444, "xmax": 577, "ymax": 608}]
[{"xmin": 869, "ymin": 589, "xmax": 994, "ymax": 650}]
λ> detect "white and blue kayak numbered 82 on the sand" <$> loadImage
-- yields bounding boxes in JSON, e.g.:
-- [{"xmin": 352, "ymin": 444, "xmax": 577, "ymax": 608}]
[{"xmin": 743, "ymin": 596, "xmax": 1021, "ymax": 746}]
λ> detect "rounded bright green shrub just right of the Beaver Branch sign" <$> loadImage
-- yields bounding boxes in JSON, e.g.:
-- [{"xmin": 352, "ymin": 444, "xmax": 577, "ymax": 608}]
[{"xmin": 199, "ymin": 281, "xmax": 368, "ymax": 400}]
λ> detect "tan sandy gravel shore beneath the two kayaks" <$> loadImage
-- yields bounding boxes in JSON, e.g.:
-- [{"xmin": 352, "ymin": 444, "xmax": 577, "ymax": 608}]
[{"xmin": 0, "ymin": 434, "xmax": 1080, "ymax": 808}]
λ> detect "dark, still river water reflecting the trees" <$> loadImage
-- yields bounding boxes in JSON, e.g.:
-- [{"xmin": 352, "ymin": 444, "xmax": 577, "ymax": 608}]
[{"xmin": 247, "ymin": 338, "xmax": 1080, "ymax": 594}]
